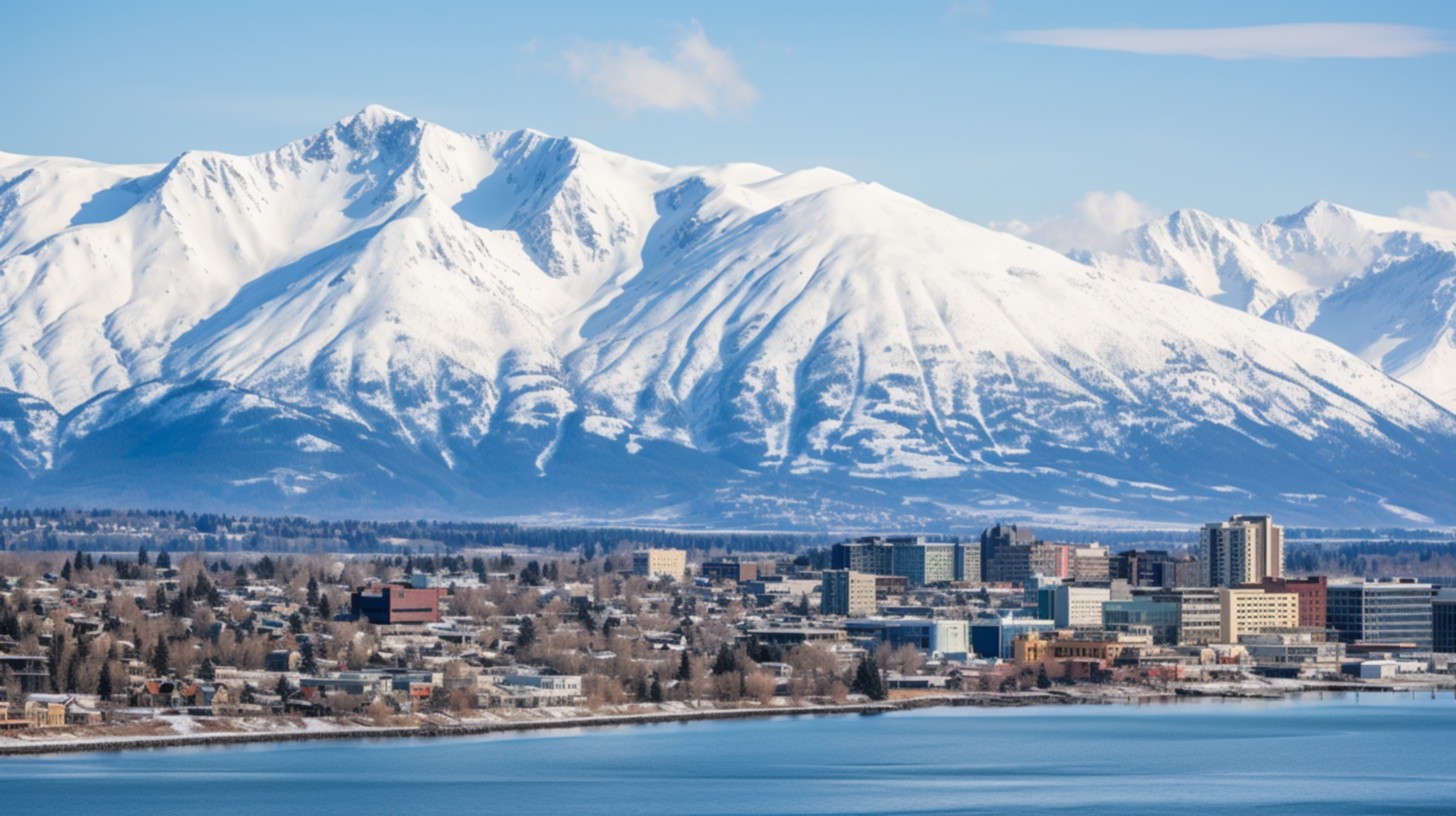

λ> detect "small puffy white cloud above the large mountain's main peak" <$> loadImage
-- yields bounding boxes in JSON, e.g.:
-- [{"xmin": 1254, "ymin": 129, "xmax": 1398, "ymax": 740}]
[{"xmin": 565, "ymin": 22, "xmax": 759, "ymax": 117}]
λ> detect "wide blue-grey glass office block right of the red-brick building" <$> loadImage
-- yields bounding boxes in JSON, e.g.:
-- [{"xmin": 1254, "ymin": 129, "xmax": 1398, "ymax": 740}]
[{"xmin": 1325, "ymin": 580, "xmax": 1434, "ymax": 651}]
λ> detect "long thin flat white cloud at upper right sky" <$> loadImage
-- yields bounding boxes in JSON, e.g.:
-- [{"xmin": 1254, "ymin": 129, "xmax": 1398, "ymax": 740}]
[{"xmin": 1002, "ymin": 23, "xmax": 1453, "ymax": 60}]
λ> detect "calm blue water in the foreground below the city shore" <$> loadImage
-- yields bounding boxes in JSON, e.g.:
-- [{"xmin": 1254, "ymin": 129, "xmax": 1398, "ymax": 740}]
[{"xmin": 0, "ymin": 692, "xmax": 1456, "ymax": 816}]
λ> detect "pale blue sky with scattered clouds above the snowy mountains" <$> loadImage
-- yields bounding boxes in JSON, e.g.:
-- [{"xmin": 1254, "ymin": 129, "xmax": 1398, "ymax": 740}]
[{"xmin": 0, "ymin": 0, "xmax": 1456, "ymax": 238}]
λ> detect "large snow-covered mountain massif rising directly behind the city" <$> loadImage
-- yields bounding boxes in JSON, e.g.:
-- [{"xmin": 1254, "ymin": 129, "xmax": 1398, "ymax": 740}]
[{"xmin": 0, "ymin": 108, "xmax": 1456, "ymax": 526}]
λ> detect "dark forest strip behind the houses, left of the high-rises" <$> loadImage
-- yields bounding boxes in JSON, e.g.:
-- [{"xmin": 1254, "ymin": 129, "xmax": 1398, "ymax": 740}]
[{"xmin": 0, "ymin": 507, "xmax": 827, "ymax": 558}]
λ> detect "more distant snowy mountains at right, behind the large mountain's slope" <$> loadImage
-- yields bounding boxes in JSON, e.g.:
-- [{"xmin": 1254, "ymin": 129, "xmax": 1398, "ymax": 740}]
[{"xmin": 1073, "ymin": 201, "xmax": 1456, "ymax": 411}]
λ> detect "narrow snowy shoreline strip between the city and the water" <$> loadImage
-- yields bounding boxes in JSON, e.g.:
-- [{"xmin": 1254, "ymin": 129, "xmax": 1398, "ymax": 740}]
[{"xmin": 0, "ymin": 683, "xmax": 1447, "ymax": 758}]
